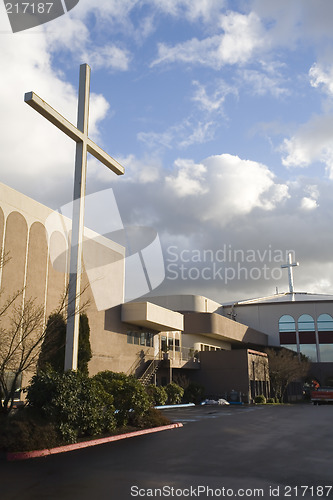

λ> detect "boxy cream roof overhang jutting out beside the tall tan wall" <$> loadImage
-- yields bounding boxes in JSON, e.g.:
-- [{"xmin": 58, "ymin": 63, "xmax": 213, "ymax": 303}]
[{"xmin": 121, "ymin": 302, "xmax": 184, "ymax": 332}]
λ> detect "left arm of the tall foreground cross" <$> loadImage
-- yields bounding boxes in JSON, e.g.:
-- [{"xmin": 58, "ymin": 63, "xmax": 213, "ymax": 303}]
[{"xmin": 24, "ymin": 92, "xmax": 84, "ymax": 142}]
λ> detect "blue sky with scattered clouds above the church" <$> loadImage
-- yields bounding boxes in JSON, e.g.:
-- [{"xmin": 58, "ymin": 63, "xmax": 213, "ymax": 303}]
[{"xmin": 0, "ymin": 0, "xmax": 333, "ymax": 301}]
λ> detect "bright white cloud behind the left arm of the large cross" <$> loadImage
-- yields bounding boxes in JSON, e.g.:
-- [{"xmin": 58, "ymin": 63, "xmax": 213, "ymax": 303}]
[{"xmin": 0, "ymin": 31, "xmax": 109, "ymax": 205}]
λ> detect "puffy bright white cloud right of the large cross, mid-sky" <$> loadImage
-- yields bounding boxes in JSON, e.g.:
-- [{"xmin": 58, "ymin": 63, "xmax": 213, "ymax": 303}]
[{"xmin": 166, "ymin": 154, "xmax": 289, "ymax": 226}]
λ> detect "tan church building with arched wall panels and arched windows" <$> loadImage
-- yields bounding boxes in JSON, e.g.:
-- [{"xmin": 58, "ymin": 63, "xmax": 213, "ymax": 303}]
[{"xmin": 0, "ymin": 184, "xmax": 333, "ymax": 401}]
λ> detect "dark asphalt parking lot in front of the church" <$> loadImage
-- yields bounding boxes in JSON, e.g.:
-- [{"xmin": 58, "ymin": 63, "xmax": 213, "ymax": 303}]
[{"xmin": 0, "ymin": 405, "xmax": 333, "ymax": 500}]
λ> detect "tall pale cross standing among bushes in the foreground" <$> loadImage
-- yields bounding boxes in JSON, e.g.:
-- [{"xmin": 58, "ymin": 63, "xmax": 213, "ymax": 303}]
[{"xmin": 24, "ymin": 64, "xmax": 125, "ymax": 370}]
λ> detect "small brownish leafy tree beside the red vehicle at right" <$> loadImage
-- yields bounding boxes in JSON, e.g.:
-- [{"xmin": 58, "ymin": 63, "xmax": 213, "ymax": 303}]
[{"xmin": 266, "ymin": 347, "xmax": 311, "ymax": 401}]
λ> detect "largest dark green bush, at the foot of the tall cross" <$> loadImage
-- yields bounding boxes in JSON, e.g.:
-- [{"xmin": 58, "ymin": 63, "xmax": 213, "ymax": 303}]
[{"xmin": 27, "ymin": 370, "xmax": 115, "ymax": 443}]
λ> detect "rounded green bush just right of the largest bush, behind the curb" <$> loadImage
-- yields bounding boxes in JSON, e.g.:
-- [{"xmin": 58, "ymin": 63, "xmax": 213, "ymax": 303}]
[{"xmin": 93, "ymin": 371, "xmax": 151, "ymax": 427}]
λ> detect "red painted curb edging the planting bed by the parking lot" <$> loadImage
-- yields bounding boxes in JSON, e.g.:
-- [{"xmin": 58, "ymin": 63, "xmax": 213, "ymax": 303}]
[{"xmin": 6, "ymin": 423, "xmax": 183, "ymax": 462}]
